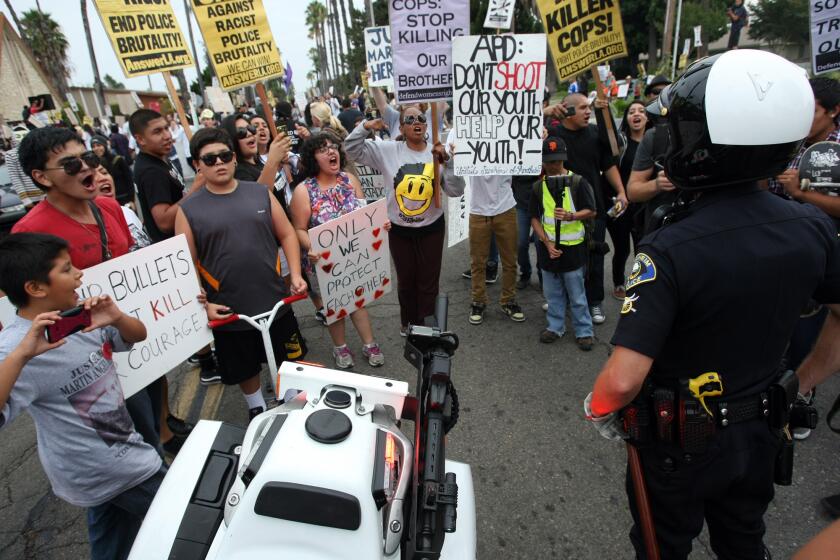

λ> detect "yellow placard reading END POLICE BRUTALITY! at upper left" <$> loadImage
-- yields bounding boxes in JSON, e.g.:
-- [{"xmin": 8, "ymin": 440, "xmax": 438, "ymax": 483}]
[{"xmin": 94, "ymin": 0, "xmax": 193, "ymax": 78}]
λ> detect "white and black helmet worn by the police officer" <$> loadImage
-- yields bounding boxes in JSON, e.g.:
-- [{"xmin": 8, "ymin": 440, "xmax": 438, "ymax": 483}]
[{"xmin": 648, "ymin": 49, "xmax": 814, "ymax": 190}]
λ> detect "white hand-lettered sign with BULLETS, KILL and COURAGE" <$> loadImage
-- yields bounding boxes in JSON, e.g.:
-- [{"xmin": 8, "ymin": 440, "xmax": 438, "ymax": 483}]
[{"xmin": 0, "ymin": 235, "xmax": 213, "ymax": 397}]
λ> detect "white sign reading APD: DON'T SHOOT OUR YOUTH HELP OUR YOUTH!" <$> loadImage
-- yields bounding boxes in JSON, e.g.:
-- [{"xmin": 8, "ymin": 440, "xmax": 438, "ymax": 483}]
[{"xmin": 452, "ymin": 34, "xmax": 545, "ymax": 176}]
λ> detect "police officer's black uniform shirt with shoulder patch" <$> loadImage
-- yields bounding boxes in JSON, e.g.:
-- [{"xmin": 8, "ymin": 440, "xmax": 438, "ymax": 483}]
[{"xmin": 612, "ymin": 185, "xmax": 840, "ymax": 398}]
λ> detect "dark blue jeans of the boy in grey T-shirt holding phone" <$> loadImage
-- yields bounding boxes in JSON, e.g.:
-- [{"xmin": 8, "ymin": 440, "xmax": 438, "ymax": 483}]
[{"xmin": 87, "ymin": 466, "xmax": 166, "ymax": 560}]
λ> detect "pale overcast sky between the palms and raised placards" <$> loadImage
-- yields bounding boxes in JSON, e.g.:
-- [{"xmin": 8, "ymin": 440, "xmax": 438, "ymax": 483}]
[{"xmin": 0, "ymin": 0, "xmax": 364, "ymax": 96}]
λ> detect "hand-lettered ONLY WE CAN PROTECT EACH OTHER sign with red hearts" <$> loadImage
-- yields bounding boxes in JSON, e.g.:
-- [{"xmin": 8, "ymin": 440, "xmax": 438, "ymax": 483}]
[{"xmin": 309, "ymin": 199, "xmax": 391, "ymax": 325}]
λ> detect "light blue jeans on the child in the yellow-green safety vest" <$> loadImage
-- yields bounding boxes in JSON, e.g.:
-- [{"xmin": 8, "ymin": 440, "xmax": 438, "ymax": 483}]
[{"xmin": 542, "ymin": 267, "xmax": 593, "ymax": 338}]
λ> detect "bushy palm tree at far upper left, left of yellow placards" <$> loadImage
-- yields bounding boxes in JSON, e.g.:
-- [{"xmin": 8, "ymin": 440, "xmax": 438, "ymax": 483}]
[{"xmin": 20, "ymin": 10, "xmax": 71, "ymax": 99}]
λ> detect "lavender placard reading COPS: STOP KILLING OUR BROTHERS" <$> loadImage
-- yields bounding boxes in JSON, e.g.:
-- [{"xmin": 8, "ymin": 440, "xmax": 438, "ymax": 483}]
[{"xmin": 388, "ymin": 0, "xmax": 470, "ymax": 103}]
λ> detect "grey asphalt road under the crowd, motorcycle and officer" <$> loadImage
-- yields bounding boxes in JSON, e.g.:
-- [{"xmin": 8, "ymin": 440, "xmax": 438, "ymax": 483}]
[{"xmin": 0, "ymin": 238, "xmax": 840, "ymax": 560}]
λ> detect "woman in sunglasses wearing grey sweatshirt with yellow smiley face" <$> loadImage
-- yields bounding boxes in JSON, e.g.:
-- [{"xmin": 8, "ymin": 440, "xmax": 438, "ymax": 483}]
[{"xmin": 344, "ymin": 106, "xmax": 464, "ymax": 334}]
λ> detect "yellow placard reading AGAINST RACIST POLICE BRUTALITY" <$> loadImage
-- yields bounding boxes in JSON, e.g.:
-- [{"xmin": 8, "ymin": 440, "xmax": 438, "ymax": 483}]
[{"xmin": 192, "ymin": 0, "xmax": 283, "ymax": 90}]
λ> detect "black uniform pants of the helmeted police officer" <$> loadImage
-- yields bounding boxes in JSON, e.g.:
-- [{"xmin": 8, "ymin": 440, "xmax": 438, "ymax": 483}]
[{"xmin": 627, "ymin": 420, "xmax": 780, "ymax": 560}]
